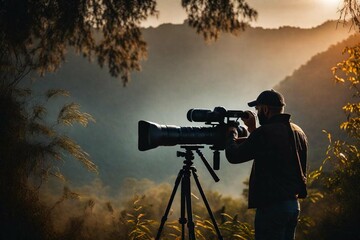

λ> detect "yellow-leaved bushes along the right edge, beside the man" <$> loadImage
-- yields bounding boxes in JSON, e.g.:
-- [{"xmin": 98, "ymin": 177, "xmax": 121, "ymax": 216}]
[{"xmin": 300, "ymin": 44, "xmax": 360, "ymax": 239}]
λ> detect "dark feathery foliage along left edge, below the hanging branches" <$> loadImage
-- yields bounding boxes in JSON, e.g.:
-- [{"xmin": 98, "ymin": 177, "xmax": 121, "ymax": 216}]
[{"xmin": 0, "ymin": 81, "xmax": 97, "ymax": 239}]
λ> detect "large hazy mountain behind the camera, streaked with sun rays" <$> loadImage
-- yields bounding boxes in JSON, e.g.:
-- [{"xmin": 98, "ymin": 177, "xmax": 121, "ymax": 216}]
[{"xmin": 33, "ymin": 22, "xmax": 358, "ymax": 197}]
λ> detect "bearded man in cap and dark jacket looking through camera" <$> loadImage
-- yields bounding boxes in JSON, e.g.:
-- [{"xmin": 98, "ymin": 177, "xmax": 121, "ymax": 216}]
[{"xmin": 226, "ymin": 90, "xmax": 307, "ymax": 240}]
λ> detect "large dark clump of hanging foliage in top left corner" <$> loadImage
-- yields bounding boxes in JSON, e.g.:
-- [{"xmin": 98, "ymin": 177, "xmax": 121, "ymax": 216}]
[{"xmin": 0, "ymin": 0, "xmax": 157, "ymax": 85}]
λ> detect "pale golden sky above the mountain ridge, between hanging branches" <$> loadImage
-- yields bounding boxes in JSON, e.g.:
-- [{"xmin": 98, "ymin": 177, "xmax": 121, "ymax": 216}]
[{"xmin": 143, "ymin": 0, "xmax": 343, "ymax": 28}]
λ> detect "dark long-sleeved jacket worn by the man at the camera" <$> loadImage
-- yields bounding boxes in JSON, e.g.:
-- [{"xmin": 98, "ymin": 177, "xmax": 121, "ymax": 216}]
[{"xmin": 226, "ymin": 114, "xmax": 307, "ymax": 208}]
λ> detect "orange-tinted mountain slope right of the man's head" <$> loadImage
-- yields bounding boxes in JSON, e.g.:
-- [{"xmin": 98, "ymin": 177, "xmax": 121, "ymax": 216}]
[{"xmin": 275, "ymin": 34, "xmax": 360, "ymax": 166}]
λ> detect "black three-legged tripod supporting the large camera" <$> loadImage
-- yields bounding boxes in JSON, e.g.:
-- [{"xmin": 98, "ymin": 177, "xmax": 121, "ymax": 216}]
[{"xmin": 155, "ymin": 146, "xmax": 223, "ymax": 240}]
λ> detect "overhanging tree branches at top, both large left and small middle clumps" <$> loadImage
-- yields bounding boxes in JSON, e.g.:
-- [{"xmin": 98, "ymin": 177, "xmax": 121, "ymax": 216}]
[{"xmin": 0, "ymin": 0, "xmax": 257, "ymax": 84}]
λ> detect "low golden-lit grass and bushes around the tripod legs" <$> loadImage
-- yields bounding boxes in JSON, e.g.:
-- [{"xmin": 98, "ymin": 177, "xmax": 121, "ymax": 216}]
[{"xmin": 46, "ymin": 186, "xmax": 254, "ymax": 240}]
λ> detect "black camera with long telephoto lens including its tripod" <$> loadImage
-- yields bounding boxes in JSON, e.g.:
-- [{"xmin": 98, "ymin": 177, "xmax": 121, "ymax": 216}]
[{"xmin": 142, "ymin": 107, "xmax": 249, "ymax": 239}]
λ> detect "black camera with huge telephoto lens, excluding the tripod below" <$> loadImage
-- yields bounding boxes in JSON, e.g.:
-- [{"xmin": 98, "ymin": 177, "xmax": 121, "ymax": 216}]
[{"xmin": 138, "ymin": 107, "xmax": 249, "ymax": 151}]
